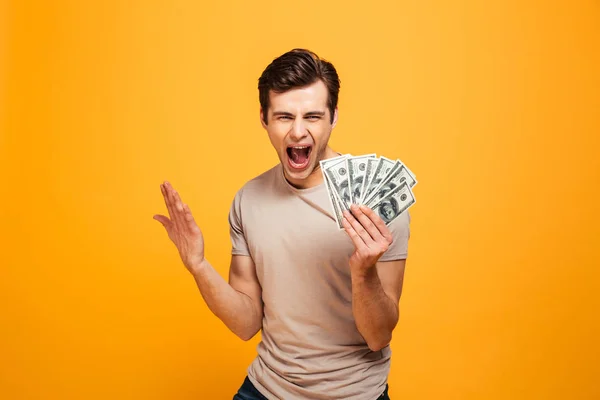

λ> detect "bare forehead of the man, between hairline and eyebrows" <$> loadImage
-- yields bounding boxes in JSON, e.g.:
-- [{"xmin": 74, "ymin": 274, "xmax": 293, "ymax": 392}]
[{"xmin": 269, "ymin": 80, "xmax": 327, "ymax": 111}]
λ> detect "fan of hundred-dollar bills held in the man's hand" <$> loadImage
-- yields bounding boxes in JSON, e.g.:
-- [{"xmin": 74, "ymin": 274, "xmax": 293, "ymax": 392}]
[{"xmin": 320, "ymin": 154, "xmax": 417, "ymax": 229}]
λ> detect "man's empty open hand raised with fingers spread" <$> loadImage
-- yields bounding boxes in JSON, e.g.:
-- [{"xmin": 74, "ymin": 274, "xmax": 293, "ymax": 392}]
[{"xmin": 153, "ymin": 182, "xmax": 204, "ymax": 273}]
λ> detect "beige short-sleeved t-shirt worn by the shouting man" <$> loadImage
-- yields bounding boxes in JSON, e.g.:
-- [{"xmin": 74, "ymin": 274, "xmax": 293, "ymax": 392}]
[{"xmin": 229, "ymin": 164, "xmax": 410, "ymax": 400}]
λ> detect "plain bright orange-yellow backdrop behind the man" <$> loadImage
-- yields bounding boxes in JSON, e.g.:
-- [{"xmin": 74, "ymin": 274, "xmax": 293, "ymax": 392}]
[{"xmin": 0, "ymin": 0, "xmax": 600, "ymax": 400}]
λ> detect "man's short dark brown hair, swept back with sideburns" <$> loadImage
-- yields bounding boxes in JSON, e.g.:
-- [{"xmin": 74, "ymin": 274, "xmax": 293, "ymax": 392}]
[{"xmin": 258, "ymin": 49, "xmax": 340, "ymax": 124}]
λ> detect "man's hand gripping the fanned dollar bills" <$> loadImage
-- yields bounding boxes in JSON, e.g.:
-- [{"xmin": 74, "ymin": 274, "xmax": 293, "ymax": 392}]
[{"xmin": 342, "ymin": 204, "xmax": 393, "ymax": 273}]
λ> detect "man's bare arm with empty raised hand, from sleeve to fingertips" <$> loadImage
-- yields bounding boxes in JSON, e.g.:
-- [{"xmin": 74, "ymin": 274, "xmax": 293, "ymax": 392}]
[{"xmin": 154, "ymin": 182, "xmax": 263, "ymax": 340}]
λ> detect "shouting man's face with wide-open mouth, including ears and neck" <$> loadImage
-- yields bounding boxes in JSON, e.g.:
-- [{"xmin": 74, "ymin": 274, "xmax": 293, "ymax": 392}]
[{"xmin": 260, "ymin": 80, "xmax": 337, "ymax": 188}]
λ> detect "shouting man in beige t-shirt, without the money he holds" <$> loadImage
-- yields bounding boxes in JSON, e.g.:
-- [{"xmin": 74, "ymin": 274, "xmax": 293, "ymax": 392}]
[{"xmin": 154, "ymin": 49, "xmax": 410, "ymax": 400}]
